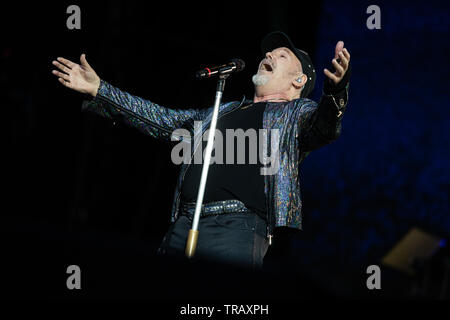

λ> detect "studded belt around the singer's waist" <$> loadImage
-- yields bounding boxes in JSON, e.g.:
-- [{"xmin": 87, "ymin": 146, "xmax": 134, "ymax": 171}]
[{"xmin": 181, "ymin": 200, "xmax": 251, "ymax": 218}]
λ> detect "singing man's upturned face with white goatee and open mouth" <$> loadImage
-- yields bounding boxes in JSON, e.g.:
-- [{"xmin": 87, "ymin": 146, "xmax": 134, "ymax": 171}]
[{"xmin": 253, "ymin": 47, "xmax": 302, "ymax": 92}]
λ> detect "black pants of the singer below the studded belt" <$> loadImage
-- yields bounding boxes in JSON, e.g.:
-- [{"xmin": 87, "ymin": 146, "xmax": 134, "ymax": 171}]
[{"xmin": 158, "ymin": 213, "xmax": 269, "ymax": 268}]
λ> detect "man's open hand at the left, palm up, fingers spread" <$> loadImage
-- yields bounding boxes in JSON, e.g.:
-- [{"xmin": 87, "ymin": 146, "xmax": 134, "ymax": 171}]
[{"xmin": 52, "ymin": 54, "xmax": 100, "ymax": 97}]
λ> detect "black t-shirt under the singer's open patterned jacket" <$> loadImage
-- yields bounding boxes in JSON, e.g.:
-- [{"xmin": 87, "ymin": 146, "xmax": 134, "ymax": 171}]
[{"xmin": 181, "ymin": 102, "xmax": 266, "ymax": 218}]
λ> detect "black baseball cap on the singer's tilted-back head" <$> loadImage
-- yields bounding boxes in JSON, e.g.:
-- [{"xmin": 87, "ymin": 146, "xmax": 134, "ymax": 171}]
[{"xmin": 261, "ymin": 31, "xmax": 316, "ymax": 98}]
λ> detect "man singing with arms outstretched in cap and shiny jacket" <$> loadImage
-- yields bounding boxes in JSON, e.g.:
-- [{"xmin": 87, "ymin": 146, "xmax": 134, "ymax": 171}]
[{"xmin": 52, "ymin": 31, "xmax": 350, "ymax": 267}]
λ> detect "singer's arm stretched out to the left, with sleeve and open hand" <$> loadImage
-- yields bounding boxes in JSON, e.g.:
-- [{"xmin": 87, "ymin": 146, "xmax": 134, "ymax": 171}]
[{"xmin": 53, "ymin": 54, "xmax": 205, "ymax": 141}]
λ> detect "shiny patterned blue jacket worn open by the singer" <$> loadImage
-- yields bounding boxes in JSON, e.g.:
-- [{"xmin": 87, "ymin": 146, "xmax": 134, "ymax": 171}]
[{"xmin": 82, "ymin": 80, "xmax": 349, "ymax": 240}]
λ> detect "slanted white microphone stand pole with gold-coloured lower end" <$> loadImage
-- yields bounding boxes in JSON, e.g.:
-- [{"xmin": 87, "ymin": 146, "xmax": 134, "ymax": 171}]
[{"xmin": 185, "ymin": 73, "xmax": 230, "ymax": 258}]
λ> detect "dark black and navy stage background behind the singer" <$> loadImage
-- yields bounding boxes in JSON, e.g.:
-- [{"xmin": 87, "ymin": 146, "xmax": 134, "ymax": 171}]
[{"xmin": 0, "ymin": 0, "xmax": 450, "ymax": 303}]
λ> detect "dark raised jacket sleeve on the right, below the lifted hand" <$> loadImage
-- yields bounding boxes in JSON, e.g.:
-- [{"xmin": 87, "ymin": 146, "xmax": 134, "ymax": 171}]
[{"xmin": 300, "ymin": 63, "xmax": 351, "ymax": 152}]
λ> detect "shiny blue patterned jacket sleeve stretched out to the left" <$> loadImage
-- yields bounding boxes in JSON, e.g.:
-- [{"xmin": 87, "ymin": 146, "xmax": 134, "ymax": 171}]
[{"xmin": 82, "ymin": 80, "xmax": 205, "ymax": 141}]
